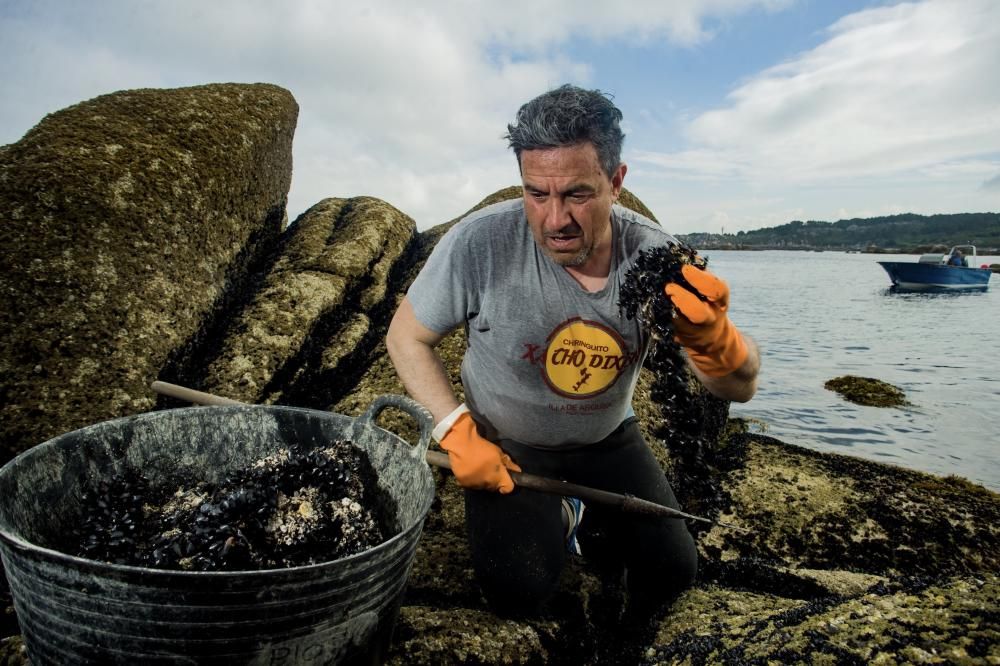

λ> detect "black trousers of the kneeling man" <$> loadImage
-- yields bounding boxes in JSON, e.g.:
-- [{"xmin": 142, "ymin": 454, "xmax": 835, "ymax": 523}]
[{"xmin": 465, "ymin": 418, "xmax": 698, "ymax": 617}]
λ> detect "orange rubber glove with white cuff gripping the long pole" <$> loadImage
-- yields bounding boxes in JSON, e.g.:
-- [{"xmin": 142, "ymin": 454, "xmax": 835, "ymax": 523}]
[{"xmin": 432, "ymin": 405, "xmax": 521, "ymax": 495}]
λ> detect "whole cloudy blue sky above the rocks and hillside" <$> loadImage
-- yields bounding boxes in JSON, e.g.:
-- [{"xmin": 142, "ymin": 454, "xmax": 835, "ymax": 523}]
[{"xmin": 0, "ymin": 0, "xmax": 1000, "ymax": 234}]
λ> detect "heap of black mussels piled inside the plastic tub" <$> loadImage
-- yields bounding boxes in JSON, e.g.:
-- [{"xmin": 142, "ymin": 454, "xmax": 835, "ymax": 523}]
[{"xmin": 60, "ymin": 441, "xmax": 396, "ymax": 571}]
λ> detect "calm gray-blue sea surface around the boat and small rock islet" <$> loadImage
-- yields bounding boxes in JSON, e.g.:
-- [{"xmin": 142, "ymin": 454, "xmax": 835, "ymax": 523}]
[{"xmin": 702, "ymin": 251, "xmax": 1000, "ymax": 491}]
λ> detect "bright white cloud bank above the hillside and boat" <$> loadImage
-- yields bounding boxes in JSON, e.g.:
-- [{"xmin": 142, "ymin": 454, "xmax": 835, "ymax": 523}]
[{"xmin": 641, "ymin": 0, "xmax": 1000, "ymax": 182}]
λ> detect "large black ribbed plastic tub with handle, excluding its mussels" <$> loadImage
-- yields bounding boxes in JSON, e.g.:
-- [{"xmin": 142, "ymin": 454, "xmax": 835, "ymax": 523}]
[{"xmin": 0, "ymin": 396, "xmax": 434, "ymax": 665}]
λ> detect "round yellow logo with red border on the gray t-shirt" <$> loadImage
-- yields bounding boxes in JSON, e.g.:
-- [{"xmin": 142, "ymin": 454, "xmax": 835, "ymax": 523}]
[{"xmin": 542, "ymin": 317, "xmax": 631, "ymax": 398}]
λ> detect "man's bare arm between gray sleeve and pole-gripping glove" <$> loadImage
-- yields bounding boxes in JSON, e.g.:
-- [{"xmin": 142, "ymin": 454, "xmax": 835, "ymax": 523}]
[{"xmin": 385, "ymin": 297, "xmax": 458, "ymax": 424}]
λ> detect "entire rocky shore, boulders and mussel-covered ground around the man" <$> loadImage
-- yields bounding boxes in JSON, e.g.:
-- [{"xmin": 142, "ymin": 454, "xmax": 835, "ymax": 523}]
[{"xmin": 0, "ymin": 84, "xmax": 1000, "ymax": 664}]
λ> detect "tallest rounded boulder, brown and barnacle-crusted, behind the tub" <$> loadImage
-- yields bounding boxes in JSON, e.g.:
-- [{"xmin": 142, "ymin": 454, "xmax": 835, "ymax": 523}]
[{"xmin": 0, "ymin": 84, "xmax": 298, "ymax": 459}]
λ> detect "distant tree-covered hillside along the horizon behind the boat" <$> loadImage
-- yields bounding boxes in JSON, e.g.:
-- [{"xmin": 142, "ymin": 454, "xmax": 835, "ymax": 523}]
[{"xmin": 680, "ymin": 213, "xmax": 1000, "ymax": 254}]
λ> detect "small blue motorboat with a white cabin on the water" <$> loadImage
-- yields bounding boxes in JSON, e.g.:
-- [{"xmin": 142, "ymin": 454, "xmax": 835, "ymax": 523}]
[{"xmin": 878, "ymin": 245, "xmax": 992, "ymax": 291}]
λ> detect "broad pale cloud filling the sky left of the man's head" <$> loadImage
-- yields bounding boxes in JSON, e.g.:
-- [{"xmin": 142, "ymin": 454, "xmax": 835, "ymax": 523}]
[{"xmin": 0, "ymin": 0, "xmax": 789, "ymax": 228}]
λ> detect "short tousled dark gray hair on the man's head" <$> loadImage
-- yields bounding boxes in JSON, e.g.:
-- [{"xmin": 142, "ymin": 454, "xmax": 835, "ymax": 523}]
[{"xmin": 504, "ymin": 83, "xmax": 625, "ymax": 178}]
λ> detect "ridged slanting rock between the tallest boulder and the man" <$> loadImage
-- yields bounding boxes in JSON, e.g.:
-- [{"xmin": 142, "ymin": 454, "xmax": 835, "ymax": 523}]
[{"xmin": 164, "ymin": 197, "xmax": 416, "ymax": 409}]
